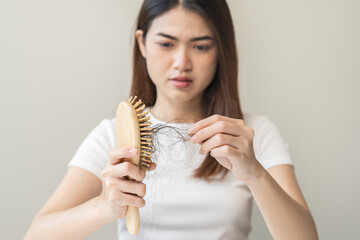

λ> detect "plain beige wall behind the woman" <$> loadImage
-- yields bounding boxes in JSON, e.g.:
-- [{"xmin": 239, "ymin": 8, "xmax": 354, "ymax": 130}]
[{"xmin": 0, "ymin": 0, "xmax": 360, "ymax": 240}]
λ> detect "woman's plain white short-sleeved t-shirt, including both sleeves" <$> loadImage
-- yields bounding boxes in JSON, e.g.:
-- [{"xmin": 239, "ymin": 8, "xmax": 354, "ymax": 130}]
[{"xmin": 69, "ymin": 109, "xmax": 292, "ymax": 240}]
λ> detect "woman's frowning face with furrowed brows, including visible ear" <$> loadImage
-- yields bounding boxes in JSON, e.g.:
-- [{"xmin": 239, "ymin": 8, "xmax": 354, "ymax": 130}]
[{"xmin": 136, "ymin": 7, "xmax": 217, "ymax": 102}]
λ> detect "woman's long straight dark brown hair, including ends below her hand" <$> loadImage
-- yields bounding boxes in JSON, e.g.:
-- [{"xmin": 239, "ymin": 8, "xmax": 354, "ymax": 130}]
[{"xmin": 130, "ymin": 0, "xmax": 243, "ymax": 180}]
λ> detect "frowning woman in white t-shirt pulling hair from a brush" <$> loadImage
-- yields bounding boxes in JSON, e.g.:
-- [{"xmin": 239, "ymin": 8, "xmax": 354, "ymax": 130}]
[{"xmin": 26, "ymin": 0, "xmax": 318, "ymax": 240}]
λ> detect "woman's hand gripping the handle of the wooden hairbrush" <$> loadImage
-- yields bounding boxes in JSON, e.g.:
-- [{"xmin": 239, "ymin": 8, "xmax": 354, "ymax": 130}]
[{"xmin": 99, "ymin": 148, "xmax": 156, "ymax": 220}]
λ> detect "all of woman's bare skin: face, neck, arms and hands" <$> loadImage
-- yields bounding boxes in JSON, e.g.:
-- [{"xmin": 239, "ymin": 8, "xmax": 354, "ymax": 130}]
[{"xmin": 25, "ymin": 7, "xmax": 318, "ymax": 240}]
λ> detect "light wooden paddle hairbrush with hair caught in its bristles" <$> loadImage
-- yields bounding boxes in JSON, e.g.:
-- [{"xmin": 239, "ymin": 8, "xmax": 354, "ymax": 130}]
[{"xmin": 116, "ymin": 96, "xmax": 153, "ymax": 235}]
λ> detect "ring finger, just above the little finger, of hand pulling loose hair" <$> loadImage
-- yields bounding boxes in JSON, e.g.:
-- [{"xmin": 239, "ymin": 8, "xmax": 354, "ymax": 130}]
[{"xmin": 201, "ymin": 133, "xmax": 241, "ymax": 154}]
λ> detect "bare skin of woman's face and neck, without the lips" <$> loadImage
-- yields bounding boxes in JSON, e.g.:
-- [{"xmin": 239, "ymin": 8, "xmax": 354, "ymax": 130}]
[{"xmin": 136, "ymin": 7, "xmax": 217, "ymax": 122}]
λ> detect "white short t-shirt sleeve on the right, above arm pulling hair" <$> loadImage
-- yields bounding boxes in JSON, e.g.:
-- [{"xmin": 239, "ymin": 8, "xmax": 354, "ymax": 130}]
[{"xmin": 254, "ymin": 116, "xmax": 293, "ymax": 169}]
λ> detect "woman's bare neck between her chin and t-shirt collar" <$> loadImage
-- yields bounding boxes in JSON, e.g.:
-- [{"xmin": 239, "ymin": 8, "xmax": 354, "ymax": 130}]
[{"xmin": 150, "ymin": 94, "xmax": 203, "ymax": 123}]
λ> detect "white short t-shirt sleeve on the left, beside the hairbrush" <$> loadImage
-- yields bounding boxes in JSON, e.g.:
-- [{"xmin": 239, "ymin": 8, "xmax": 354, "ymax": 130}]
[{"xmin": 68, "ymin": 119, "xmax": 116, "ymax": 179}]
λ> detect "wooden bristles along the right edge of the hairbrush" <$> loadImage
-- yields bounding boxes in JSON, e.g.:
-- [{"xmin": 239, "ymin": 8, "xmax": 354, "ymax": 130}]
[{"xmin": 129, "ymin": 96, "xmax": 153, "ymax": 170}]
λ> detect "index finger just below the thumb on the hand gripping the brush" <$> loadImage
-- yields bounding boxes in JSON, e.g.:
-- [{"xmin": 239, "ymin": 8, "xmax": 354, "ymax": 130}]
[{"xmin": 111, "ymin": 162, "xmax": 145, "ymax": 182}]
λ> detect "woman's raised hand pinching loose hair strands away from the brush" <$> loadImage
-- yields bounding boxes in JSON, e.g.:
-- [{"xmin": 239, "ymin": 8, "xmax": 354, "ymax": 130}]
[{"xmin": 188, "ymin": 114, "xmax": 260, "ymax": 181}]
